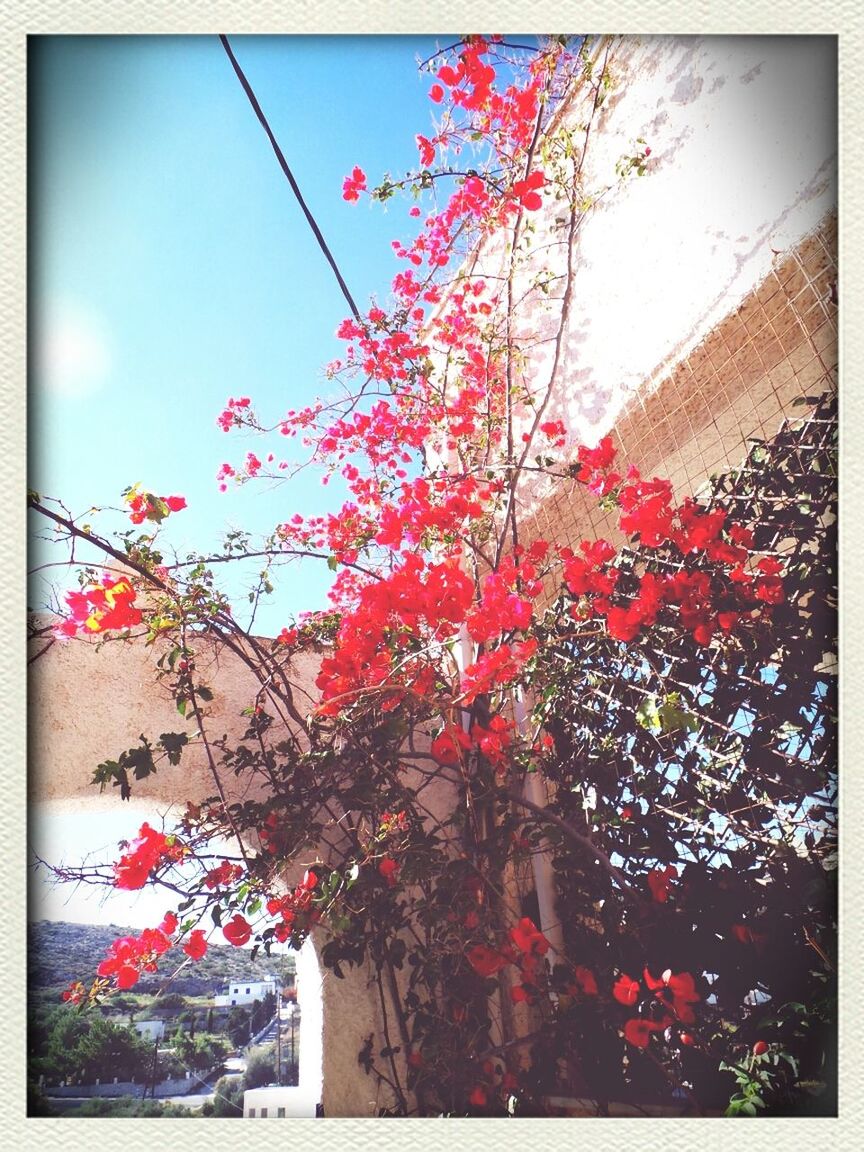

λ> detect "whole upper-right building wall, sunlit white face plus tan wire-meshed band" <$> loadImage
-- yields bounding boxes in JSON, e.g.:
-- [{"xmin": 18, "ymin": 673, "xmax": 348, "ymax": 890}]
[{"xmin": 467, "ymin": 37, "xmax": 838, "ymax": 523}]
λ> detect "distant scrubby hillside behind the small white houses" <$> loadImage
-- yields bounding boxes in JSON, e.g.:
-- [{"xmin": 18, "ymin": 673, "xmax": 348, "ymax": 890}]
[{"xmin": 28, "ymin": 920, "xmax": 295, "ymax": 995}]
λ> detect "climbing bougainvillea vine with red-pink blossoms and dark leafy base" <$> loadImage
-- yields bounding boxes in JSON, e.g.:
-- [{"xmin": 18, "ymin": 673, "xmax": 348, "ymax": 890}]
[{"xmin": 30, "ymin": 37, "xmax": 835, "ymax": 1115}]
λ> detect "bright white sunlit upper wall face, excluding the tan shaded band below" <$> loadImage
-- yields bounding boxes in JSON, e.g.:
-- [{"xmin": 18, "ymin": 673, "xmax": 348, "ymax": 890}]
[{"xmin": 559, "ymin": 36, "xmax": 838, "ymax": 439}]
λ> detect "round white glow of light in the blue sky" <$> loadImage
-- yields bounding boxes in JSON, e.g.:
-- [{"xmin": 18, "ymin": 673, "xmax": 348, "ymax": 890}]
[{"xmin": 32, "ymin": 305, "xmax": 111, "ymax": 400}]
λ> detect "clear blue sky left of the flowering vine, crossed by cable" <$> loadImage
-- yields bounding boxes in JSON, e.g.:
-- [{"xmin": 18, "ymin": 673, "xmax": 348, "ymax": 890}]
[{"xmin": 29, "ymin": 36, "xmax": 453, "ymax": 634}]
